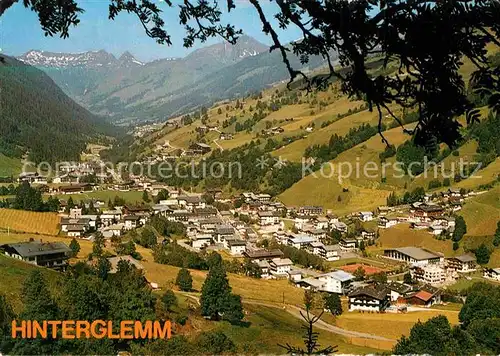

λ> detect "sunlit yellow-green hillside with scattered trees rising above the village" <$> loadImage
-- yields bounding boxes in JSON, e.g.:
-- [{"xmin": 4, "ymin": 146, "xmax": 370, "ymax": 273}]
[{"xmin": 133, "ymin": 47, "xmax": 500, "ymax": 213}]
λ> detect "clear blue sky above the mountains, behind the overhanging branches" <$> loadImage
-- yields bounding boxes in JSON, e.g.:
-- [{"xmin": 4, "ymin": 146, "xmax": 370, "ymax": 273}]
[{"xmin": 0, "ymin": 0, "xmax": 299, "ymax": 61}]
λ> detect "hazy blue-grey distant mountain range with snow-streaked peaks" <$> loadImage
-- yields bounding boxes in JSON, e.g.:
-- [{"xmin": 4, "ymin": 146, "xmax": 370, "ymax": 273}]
[{"xmin": 18, "ymin": 36, "xmax": 334, "ymax": 123}]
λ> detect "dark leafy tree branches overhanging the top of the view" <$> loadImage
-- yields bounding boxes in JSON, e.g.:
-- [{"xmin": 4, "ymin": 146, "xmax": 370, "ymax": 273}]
[{"xmin": 7, "ymin": 0, "xmax": 500, "ymax": 146}]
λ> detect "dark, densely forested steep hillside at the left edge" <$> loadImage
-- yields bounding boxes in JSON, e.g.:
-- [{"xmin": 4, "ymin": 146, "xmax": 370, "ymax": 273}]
[{"xmin": 0, "ymin": 57, "xmax": 113, "ymax": 163}]
